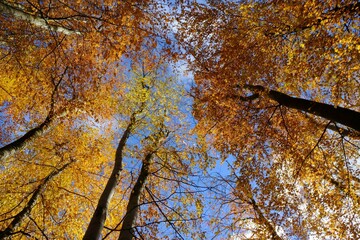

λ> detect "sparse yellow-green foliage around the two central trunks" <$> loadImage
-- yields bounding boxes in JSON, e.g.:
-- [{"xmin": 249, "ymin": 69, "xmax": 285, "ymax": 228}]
[{"xmin": 84, "ymin": 53, "xmax": 208, "ymax": 236}]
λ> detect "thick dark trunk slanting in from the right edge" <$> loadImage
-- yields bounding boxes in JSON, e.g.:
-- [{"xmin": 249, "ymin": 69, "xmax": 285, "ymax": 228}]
[{"xmin": 240, "ymin": 85, "xmax": 360, "ymax": 132}]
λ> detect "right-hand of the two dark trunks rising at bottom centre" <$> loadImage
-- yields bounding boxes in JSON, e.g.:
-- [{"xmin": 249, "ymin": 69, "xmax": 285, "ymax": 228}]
[{"xmin": 119, "ymin": 152, "xmax": 153, "ymax": 240}]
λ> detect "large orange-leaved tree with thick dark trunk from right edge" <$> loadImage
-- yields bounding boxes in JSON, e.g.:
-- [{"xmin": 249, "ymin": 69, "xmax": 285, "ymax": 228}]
[{"xmin": 178, "ymin": 1, "xmax": 360, "ymax": 239}]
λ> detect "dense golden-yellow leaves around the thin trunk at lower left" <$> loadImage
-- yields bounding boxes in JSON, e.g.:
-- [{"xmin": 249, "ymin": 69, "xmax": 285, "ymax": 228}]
[{"xmin": 0, "ymin": 118, "xmax": 114, "ymax": 238}]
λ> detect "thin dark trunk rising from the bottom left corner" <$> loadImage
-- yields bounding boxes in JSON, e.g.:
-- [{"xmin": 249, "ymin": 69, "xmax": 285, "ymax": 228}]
[{"xmin": 0, "ymin": 161, "xmax": 73, "ymax": 240}]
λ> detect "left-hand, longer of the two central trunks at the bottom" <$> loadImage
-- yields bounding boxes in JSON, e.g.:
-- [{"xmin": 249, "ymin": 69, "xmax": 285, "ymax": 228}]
[{"xmin": 83, "ymin": 113, "xmax": 136, "ymax": 240}]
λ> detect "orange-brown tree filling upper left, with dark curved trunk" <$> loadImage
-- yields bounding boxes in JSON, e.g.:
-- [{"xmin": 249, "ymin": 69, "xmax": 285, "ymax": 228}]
[{"xmin": 0, "ymin": 1, "xmax": 169, "ymax": 161}]
